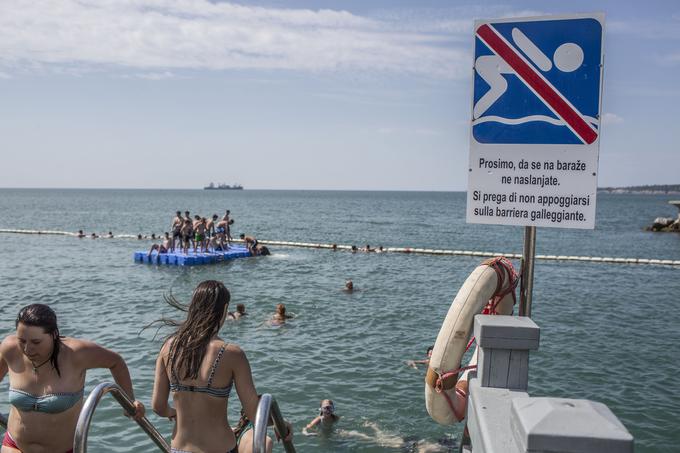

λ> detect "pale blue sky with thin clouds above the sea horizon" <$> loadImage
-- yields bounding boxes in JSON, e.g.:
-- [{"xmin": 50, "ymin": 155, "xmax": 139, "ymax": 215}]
[{"xmin": 0, "ymin": 0, "xmax": 680, "ymax": 191}]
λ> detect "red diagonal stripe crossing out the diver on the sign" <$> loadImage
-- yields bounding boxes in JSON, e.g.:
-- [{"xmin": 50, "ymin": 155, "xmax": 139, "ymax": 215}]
[{"xmin": 477, "ymin": 24, "xmax": 597, "ymax": 145}]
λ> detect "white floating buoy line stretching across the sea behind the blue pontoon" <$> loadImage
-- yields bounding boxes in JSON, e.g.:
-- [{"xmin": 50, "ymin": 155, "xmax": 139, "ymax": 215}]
[{"xmin": 0, "ymin": 228, "xmax": 680, "ymax": 267}]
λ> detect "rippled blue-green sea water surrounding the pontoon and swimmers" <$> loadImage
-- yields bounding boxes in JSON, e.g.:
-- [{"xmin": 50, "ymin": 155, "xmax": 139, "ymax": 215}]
[{"xmin": 0, "ymin": 189, "xmax": 680, "ymax": 453}]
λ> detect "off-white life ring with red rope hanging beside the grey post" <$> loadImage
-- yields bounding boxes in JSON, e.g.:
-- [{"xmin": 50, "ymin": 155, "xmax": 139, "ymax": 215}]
[{"xmin": 425, "ymin": 257, "xmax": 519, "ymax": 425}]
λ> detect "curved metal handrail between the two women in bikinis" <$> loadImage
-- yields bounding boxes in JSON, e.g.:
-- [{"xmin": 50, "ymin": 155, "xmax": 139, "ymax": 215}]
[{"xmin": 73, "ymin": 382, "xmax": 170, "ymax": 453}]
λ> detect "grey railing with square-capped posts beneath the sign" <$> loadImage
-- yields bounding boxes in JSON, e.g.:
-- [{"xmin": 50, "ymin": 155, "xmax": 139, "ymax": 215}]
[{"xmin": 467, "ymin": 315, "xmax": 633, "ymax": 453}]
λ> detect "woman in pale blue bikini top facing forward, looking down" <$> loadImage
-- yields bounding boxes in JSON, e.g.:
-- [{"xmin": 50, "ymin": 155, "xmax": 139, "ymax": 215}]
[{"xmin": 0, "ymin": 304, "xmax": 144, "ymax": 453}]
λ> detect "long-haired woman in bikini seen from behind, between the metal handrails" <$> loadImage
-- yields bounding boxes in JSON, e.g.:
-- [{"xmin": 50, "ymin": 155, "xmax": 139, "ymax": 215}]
[{"xmin": 152, "ymin": 280, "xmax": 293, "ymax": 453}]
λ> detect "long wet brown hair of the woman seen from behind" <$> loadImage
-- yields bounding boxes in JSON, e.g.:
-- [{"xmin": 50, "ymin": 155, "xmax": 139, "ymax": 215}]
[{"xmin": 164, "ymin": 280, "xmax": 231, "ymax": 379}]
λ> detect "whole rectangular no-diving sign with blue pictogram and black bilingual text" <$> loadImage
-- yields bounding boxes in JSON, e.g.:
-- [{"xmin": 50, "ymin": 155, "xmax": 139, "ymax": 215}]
[{"xmin": 467, "ymin": 14, "xmax": 604, "ymax": 228}]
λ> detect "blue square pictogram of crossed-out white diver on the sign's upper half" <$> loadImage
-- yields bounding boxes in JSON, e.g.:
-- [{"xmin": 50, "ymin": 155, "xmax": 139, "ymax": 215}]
[{"xmin": 472, "ymin": 18, "xmax": 602, "ymax": 145}]
